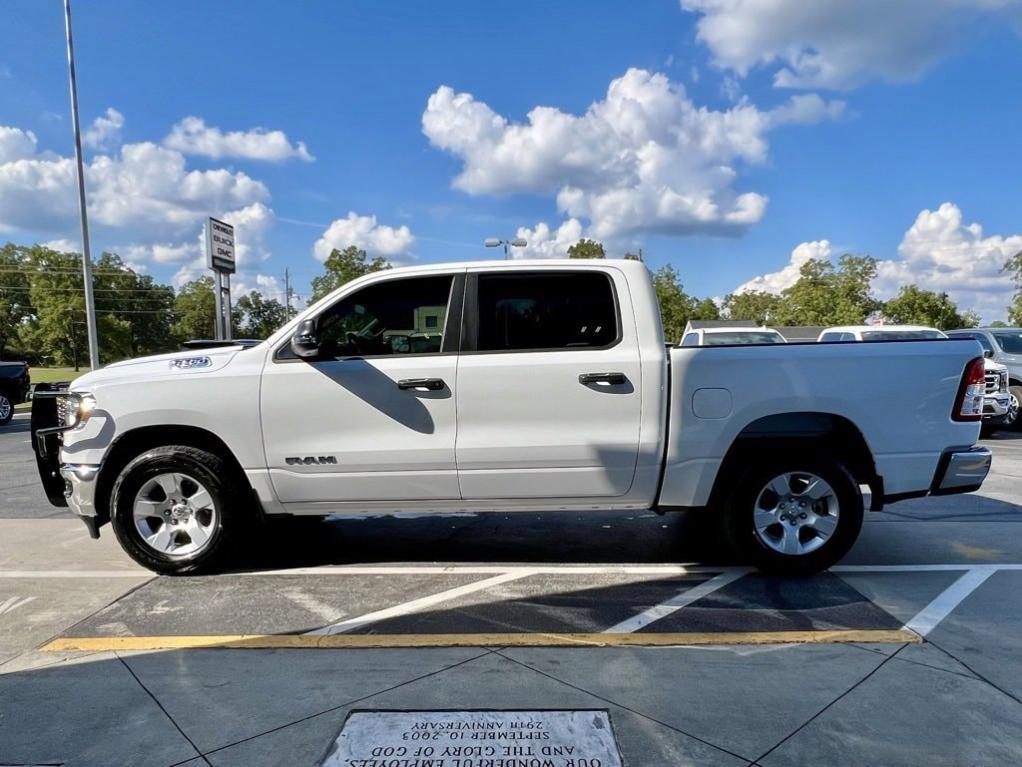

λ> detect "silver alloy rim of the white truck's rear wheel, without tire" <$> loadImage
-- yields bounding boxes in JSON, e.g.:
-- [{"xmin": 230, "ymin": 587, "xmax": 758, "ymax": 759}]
[{"xmin": 753, "ymin": 471, "xmax": 840, "ymax": 556}]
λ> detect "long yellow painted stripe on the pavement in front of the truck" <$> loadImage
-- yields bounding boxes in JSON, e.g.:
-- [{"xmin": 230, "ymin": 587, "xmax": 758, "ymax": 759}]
[{"xmin": 41, "ymin": 629, "xmax": 922, "ymax": 652}]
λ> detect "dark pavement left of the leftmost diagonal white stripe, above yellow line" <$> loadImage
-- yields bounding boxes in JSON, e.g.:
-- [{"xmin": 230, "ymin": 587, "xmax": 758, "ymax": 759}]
[{"xmin": 66, "ymin": 573, "xmax": 482, "ymax": 636}]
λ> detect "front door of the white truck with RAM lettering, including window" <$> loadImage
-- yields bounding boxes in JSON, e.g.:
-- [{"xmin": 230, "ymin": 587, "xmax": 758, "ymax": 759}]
[{"xmin": 261, "ymin": 272, "xmax": 464, "ymax": 504}]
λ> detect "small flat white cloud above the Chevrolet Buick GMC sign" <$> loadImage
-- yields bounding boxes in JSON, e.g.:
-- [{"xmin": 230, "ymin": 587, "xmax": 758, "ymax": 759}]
[{"xmin": 164, "ymin": 117, "xmax": 315, "ymax": 163}]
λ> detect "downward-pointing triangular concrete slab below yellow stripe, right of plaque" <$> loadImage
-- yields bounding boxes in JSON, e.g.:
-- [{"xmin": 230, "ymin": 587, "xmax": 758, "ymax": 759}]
[{"xmin": 502, "ymin": 644, "xmax": 884, "ymax": 760}]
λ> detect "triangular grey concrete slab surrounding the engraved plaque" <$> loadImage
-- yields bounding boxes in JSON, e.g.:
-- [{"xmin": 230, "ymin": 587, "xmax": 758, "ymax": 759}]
[{"xmin": 201, "ymin": 655, "xmax": 746, "ymax": 767}]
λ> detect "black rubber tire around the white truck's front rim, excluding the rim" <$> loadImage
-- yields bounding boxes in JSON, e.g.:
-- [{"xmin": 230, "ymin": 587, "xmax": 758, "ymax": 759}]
[{"xmin": 110, "ymin": 445, "xmax": 243, "ymax": 575}]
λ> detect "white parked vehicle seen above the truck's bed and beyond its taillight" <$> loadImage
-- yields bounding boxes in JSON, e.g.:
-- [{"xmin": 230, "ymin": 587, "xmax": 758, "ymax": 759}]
[{"xmin": 817, "ymin": 325, "xmax": 1009, "ymax": 433}]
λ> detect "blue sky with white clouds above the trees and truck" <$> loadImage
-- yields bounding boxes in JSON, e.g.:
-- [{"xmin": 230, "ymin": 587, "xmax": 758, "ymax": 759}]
[{"xmin": 0, "ymin": 0, "xmax": 1022, "ymax": 319}]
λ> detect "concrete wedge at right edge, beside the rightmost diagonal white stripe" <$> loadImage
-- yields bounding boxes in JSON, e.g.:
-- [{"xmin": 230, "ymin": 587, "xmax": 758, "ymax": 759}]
[{"xmin": 928, "ymin": 571, "xmax": 1022, "ymax": 698}]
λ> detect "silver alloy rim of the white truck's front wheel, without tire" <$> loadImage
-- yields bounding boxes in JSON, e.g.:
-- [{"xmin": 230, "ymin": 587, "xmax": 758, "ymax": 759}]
[{"xmin": 133, "ymin": 471, "xmax": 217, "ymax": 557}]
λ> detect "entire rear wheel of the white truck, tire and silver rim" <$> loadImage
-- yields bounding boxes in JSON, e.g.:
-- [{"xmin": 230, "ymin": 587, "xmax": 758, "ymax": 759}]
[{"xmin": 725, "ymin": 457, "xmax": 863, "ymax": 575}]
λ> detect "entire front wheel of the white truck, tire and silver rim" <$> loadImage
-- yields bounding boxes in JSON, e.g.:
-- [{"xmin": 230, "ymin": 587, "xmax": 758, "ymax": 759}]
[{"xmin": 110, "ymin": 445, "xmax": 246, "ymax": 575}]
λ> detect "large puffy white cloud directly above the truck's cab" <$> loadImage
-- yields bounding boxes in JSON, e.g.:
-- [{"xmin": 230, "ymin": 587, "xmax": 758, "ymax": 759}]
[{"xmin": 422, "ymin": 69, "xmax": 843, "ymax": 239}]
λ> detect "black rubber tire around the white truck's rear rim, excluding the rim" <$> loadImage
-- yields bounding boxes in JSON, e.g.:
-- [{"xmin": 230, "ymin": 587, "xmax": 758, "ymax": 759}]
[{"xmin": 724, "ymin": 455, "xmax": 864, "ymax": 576}]
